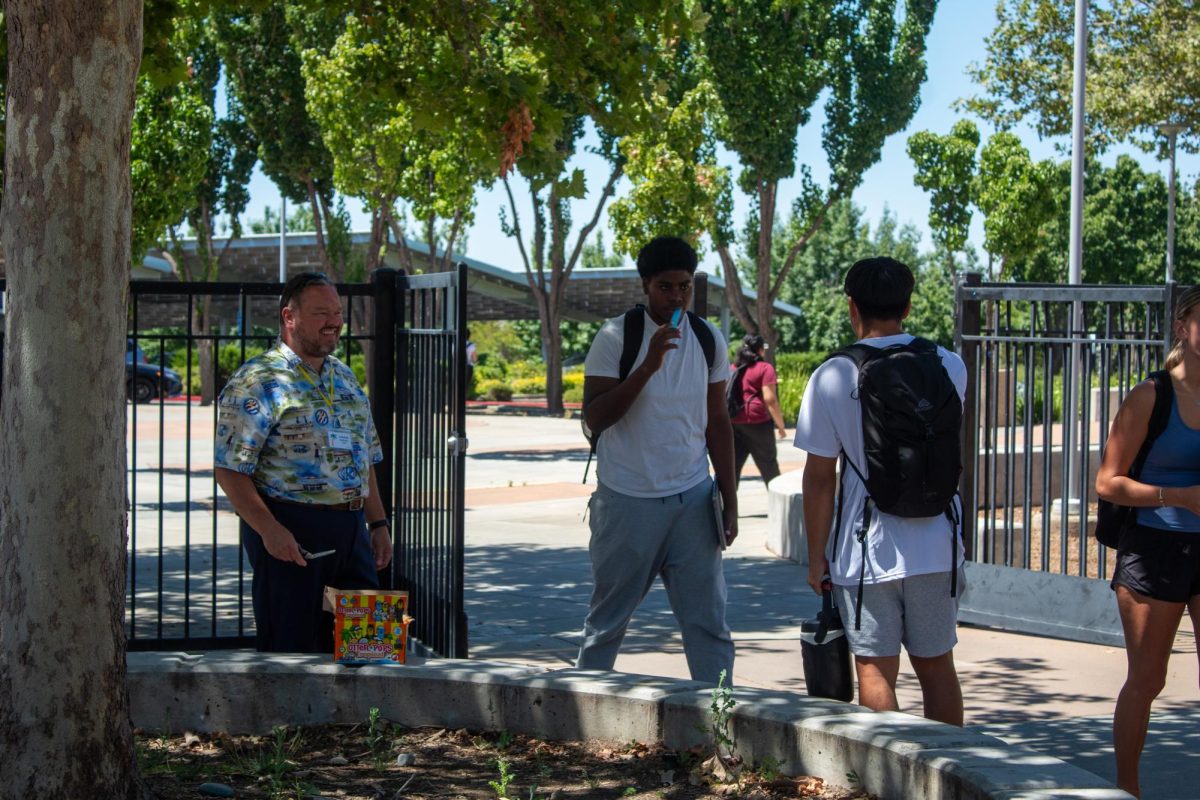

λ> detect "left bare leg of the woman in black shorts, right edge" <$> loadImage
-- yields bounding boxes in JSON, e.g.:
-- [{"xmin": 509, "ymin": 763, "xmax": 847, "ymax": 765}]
[{"xmin": 1112, "ymin": 585, "xmax": 1185, "ymax": 798}]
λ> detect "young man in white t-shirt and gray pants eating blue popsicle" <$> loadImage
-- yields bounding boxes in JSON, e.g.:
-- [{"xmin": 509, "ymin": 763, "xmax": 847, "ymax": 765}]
[{"xmin": 576, "ymin": 236, "xmax": 738, "ymax": 685}]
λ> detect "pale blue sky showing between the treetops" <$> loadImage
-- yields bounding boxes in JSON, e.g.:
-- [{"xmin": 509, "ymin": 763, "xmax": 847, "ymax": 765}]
[{"xmin": 238, "ymin": 0, "xmax": 1200, "ymax": 270}]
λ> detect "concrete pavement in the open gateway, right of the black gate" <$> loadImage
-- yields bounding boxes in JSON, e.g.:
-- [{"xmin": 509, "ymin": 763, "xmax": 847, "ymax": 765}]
[{"xmin": 466, "ymin": 415, "xmax": 1200, "ymax": 800}]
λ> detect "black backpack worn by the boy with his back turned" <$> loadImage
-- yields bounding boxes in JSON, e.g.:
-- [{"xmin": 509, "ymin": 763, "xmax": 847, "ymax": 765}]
[{"xmin": 830, "ymin": 338, "xmax": 962, "ymax": 627}]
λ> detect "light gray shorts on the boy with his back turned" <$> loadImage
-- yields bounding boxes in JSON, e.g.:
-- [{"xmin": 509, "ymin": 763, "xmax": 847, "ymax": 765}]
[{"xmin": 834, "ymin": 571, "xmax": 966, "ymax": 658}]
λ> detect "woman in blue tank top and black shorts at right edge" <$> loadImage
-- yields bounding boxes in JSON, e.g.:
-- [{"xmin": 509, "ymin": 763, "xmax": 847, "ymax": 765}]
[{"xmin": 1096, "ymin": 287, "xmax": 1200, "ymax": 796}]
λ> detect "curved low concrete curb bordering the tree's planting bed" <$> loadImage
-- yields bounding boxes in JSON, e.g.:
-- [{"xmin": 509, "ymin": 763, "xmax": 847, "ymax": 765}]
[{"xmin": 128, "ymin": 651, "xmax": 1130, "ymax": 800}]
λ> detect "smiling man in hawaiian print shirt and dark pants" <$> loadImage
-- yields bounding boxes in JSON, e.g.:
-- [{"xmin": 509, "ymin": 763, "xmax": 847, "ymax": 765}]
[{"xmin": 214, "ymin": 272, "xmax": 391, "ymax": 652}]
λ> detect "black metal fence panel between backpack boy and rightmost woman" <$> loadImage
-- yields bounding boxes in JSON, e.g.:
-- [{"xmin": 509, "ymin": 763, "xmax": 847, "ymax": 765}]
[{"xmin": 956, "ymin": 273, "xmax": 1177, "ymax": 578}]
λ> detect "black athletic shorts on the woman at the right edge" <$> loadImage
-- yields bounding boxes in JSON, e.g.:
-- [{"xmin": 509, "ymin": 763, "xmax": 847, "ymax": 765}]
[{"xmin": 1112, "ymin": 524, "xmax": 1200, "ymax": 603}]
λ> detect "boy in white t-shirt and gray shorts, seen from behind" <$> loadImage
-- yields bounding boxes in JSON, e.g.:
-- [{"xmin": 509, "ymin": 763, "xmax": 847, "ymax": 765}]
[{"xmin": 796, "ymin": 257, "xmax": 966, "ymax": 726}]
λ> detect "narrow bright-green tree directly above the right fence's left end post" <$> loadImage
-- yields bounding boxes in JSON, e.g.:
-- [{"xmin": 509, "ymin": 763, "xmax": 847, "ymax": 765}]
[{"xmin": 908, "ymin": 120, "xmax": 979, "ymax": 268}]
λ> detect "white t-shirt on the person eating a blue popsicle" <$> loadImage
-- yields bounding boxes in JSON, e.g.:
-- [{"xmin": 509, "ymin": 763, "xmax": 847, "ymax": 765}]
[{"xmin": 583, "ymin": 313, "xmax": 730, "ymax": 498}]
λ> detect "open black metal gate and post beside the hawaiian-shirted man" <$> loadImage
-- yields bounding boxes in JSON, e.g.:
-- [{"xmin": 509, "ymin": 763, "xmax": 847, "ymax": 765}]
[{"xmin": 372, "ymin": 265, "xmax": 467, "ymax": 658}]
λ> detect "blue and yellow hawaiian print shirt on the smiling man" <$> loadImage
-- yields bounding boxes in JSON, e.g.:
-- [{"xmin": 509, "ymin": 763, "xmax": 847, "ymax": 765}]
[{"xmin": 214, "ymin": 342, "xmax": 383, "ymax": 505}]
